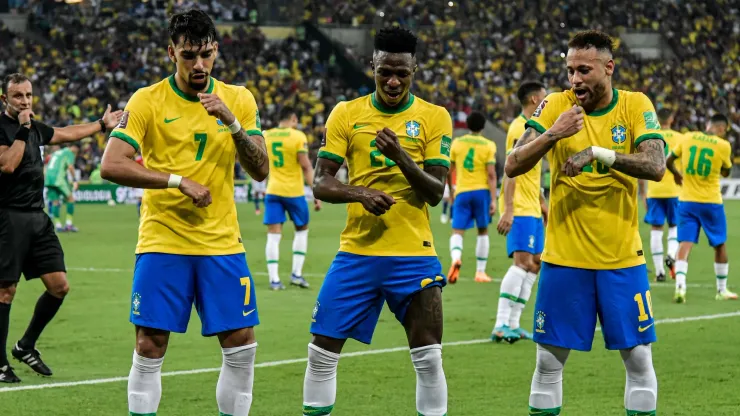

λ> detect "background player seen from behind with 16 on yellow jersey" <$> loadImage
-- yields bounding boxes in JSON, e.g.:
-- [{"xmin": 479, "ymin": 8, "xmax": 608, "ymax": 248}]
[{"xmin": 666, "ymin": 114, "xmax": 738, "ymax": 303}]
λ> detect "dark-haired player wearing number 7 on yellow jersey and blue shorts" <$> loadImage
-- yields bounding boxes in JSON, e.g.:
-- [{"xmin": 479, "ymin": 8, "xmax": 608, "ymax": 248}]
[{"xmin": 101, "ymin": 10, "xmax": 269, "ymax": 416}]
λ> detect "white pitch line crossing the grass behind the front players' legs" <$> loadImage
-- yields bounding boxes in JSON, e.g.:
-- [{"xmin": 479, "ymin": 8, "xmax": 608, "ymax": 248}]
[{"xmin": 0, "ymin": 311, "xmax": 740, "ymax": 393}]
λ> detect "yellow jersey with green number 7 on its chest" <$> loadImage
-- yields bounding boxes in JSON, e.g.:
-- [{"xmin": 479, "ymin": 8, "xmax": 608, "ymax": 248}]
[{"xmin": 111, "ymin": 76, "xmax": 262, "ymax": 255}]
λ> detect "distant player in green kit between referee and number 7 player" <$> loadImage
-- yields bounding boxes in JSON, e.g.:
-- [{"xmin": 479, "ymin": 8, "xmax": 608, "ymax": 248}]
[{"xmin": 44, "ymin": 145, "xmax": 80, "ymax": 232}]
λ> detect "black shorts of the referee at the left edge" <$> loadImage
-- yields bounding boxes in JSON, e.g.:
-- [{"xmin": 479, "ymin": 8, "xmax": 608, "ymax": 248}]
[{"xmin": 0, "ymin": 208, "xmax": 66, "ymax": 283}]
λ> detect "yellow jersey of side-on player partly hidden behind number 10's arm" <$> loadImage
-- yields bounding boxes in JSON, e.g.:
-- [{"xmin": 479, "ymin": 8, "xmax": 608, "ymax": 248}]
[{"xmin": 498, "ymin": 114, "xmax": 542, "ymax": 218}]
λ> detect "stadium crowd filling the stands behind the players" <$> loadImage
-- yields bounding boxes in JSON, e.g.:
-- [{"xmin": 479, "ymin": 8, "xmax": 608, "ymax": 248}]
[{"xmin": 0, "ymin": 0, "xmax": 740, "ymax": 177}]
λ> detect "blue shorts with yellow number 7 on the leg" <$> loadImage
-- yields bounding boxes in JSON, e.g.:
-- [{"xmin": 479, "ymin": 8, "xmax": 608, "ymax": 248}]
[{"xmin": 130, "ymin": 253, "xmax": 259, "ymax": 336}]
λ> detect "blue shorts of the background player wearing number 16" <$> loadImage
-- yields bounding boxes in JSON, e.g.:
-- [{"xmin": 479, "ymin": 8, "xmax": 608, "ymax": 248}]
[{"xmin": 678, "ymin": 202, "xmax": 727, "ymax": 247}]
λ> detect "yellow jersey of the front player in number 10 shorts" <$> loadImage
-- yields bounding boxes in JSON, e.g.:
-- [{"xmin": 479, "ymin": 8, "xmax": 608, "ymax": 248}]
[{"xmin": 527, "ymin": 89, "xmax": 662, "ymax": 270}]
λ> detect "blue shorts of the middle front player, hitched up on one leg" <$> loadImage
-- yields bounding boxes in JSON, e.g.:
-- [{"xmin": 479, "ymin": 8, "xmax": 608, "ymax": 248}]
[{"xmin": 311, "ymin": 252, "xmax": 447, "ymax": 344}]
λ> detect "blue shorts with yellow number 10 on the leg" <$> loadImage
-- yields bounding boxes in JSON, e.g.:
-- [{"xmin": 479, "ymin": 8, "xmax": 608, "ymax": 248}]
[{"xmin": 534, "ymin": 262, "xmax": 657, "ymax": 351}]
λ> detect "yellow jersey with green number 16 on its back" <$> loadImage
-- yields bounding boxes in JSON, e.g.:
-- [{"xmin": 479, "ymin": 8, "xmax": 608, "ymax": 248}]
[{"xmin": 673, "ymin": 132, "xmax": 732, "ymax": 204}]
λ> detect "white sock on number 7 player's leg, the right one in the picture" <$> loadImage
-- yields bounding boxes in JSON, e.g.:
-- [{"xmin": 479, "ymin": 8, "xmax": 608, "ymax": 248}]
[{"xmin": 216, "ymin": 342, "xmax": 257, "ymax": 416}]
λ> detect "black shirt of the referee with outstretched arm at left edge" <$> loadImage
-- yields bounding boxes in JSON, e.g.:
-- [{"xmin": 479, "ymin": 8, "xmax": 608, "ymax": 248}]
[{"xmin": 0, "ymin": 112, "xmax": 54, "ymax": 211}]
